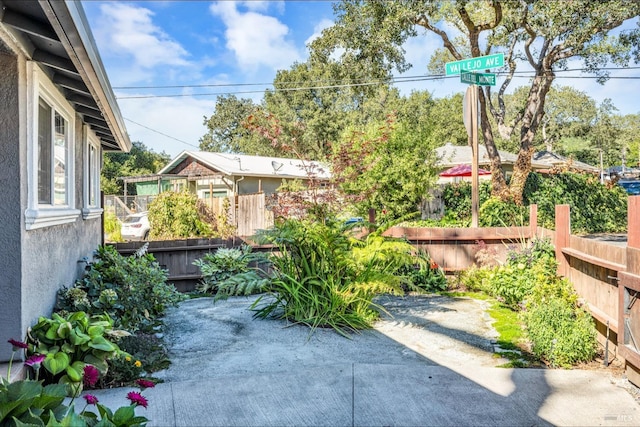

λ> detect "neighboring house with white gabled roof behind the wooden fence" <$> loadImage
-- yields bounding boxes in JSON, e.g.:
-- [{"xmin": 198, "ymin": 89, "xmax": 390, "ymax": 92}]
[{"xmin": 123, "ymin": 151, "xmax": 330, "ymax": 199}]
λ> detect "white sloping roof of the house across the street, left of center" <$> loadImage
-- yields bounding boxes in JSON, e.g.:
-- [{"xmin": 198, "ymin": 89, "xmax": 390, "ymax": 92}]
[{"xmin": 158, "ymin": 151, "xmax": 331, "ymax": 179}]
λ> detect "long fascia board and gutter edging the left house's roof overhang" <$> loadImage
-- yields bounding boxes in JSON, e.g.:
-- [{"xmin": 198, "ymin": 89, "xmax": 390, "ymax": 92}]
[{"xmin": 39, "ymin": 0, "xmax": 132, "ymax": 152}]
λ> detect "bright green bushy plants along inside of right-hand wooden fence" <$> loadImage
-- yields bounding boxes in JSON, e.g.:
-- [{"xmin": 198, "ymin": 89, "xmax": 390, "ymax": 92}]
[{"xmin": 460, "ymin": 239, "xmax": 597, "ymax": 366}]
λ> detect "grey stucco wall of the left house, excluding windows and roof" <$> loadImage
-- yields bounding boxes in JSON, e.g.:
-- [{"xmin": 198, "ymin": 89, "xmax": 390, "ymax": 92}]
[{"xmin": 0, "ymin": 40, "xmax": 101, "ymax": 362}]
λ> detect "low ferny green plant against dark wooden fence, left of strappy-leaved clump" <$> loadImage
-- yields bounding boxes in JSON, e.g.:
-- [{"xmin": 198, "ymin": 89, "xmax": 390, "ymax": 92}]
[{"xmin": 193, "ymin": 245, "xmax": 269, "ymax": 300}]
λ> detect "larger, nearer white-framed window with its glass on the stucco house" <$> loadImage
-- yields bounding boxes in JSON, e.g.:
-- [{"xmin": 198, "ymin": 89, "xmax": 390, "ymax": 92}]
[{"xmin": 25, "ymin": 62, "xmax": 80, "ymax": 230}]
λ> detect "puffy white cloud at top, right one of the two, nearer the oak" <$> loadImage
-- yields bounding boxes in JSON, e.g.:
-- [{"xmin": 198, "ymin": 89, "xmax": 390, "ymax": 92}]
[{"xmin": 210, "ymin": 2, "xmax": 302, "ymax": 72}]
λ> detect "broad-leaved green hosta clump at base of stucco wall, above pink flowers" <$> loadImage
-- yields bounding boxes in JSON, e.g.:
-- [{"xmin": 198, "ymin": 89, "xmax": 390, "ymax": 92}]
[{"xmin": 27, "ymin": 311, "xmax": 122, "ymax": 387}]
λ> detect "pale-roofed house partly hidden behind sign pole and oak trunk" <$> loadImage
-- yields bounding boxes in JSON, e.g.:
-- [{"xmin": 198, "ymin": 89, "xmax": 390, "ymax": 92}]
[{"xmin": 436, "ymin": 142, "xmax": 550, "ymax": 184}]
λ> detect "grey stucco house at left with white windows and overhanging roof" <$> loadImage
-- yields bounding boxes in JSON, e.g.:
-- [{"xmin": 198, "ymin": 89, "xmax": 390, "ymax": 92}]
[{"xmin": 0, "ymin": 0, "xmax": 131, "ymax": 361}]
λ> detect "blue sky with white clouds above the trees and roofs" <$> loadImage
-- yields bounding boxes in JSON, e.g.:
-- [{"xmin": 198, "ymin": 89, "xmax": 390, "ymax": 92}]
[{"xmin": 82, "ymin": 0, "xmax": 640, "ymax": 157}]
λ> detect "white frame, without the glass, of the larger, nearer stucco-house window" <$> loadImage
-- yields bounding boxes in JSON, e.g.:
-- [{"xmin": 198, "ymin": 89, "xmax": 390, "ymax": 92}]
[{"xmin": 25, "ymin": 61, "xmax": 80, "ymax": 230}]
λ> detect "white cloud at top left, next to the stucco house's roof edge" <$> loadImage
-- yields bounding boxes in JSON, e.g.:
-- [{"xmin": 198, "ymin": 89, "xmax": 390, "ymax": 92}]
[{"xmin": 96, "ymin": 2, "xmax": 189, "ymax": 69}]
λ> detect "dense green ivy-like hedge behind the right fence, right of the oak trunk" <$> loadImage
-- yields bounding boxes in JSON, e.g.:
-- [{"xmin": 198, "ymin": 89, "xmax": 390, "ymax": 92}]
[{"xmin": 524, "ymin": 173, "xmax": 628, "ymax": 233}]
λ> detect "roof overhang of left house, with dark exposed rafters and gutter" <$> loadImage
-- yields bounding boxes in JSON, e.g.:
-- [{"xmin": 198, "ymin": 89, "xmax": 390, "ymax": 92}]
[{"xmin": 0, "ymin": 0, "xmax": 131, "ymax": 151}]
